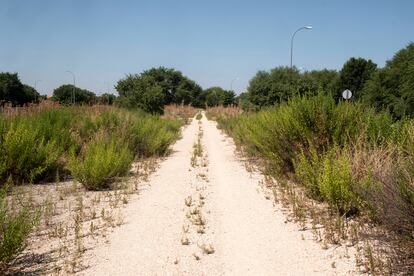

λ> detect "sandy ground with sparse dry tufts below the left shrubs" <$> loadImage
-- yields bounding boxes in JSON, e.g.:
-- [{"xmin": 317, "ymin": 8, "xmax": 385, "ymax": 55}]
[{"xmin": 9, "ymin": 159, "xmax": 157, "ymax": 275}]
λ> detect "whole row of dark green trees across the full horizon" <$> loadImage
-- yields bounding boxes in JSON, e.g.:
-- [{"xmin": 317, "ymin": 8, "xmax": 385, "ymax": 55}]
[{"xmin": 0, "ymin": 43, "xmax": 414, "ymax": 118}]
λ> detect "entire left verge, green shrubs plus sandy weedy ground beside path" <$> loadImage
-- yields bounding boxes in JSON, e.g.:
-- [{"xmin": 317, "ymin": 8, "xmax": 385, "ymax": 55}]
[{"xmin": 0, "ymin": 104, "xmax": 188, "ymax": 274}]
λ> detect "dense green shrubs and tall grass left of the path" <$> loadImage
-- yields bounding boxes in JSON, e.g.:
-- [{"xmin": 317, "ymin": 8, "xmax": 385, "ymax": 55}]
[{"xmin": 0, "ymin": 106, "xmax": 181, "ymax": 189}]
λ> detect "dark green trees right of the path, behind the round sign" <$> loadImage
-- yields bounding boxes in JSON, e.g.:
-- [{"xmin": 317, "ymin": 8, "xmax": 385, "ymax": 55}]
[{"xmin": 243, "ymin": 43, "xmax": 414, "ymax": 118}]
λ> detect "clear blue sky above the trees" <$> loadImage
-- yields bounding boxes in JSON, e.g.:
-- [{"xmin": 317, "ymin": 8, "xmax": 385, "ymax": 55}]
[{"xmin": 0, "ymin": 0, "xmax": 414, "ymax": 95}]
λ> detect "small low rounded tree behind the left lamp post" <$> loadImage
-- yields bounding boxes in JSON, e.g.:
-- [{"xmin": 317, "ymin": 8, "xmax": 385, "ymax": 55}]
[{"xmin": 53, "ymin": 84, "xmax": 97, "ymax": 105}]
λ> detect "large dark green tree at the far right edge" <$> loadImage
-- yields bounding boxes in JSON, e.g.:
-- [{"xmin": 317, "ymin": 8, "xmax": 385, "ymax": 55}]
[{"xmin": 363, "ymin": 43, "xmax": 414, "ymax": 118}]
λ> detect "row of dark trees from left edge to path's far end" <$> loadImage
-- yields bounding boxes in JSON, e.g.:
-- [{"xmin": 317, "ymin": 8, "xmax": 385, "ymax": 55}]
[{"xmin": 0, "ymin": 67, "xmax": 236, "ymax": 113}]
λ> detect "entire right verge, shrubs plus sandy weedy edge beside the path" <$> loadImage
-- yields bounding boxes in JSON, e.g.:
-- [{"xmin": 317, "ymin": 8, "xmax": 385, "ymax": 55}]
[{"xmin": 209, "ymin": 96, "xmax": 414, "ymax": 274}]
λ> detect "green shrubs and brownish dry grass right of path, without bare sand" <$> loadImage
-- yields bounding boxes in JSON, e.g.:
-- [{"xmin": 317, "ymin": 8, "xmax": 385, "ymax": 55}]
[{"xmin": 209, "ymin": 95, "xmax": 414, "ymax": 272}]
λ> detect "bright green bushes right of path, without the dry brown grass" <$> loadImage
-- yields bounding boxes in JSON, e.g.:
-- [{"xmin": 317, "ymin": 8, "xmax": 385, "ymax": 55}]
[{"xmin": 218, "ymin": 94, "xmax": 407, "ymax": 217}]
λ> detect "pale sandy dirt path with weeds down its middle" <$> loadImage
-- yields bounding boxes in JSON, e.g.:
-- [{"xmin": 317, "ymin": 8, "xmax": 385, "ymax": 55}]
[{"xmin": 82, "ymin": 113, "xmax": 355, "ymax": 275}]
